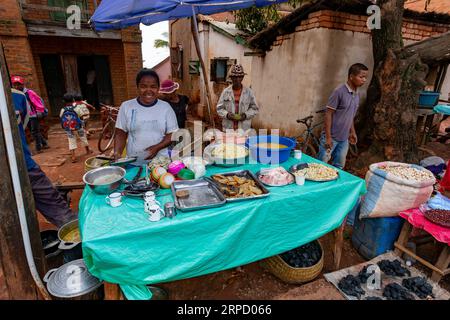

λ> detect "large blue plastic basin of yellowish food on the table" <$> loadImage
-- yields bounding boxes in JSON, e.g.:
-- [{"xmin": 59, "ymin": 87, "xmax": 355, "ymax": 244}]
[{"xmin": 245, "ymin": 135, "xmax": 296, "ymax": 164}]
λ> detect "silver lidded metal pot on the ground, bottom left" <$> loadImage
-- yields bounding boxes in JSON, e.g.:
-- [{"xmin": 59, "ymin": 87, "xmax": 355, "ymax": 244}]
[{"xmin": 43, "ymin": 259, "xmax": 104, "ymax": 300}]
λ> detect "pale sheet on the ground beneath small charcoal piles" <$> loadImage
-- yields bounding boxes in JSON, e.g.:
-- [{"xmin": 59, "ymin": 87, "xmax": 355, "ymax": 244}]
[{"xmin": 324, "ymin": 251, "xmax": 450, "ymax": 300}]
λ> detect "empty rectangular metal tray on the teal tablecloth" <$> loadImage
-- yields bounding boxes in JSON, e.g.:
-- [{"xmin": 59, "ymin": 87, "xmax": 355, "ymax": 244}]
[{"xmin": 170, "ymin": 178, "xmax": 226, "ymax": 211}]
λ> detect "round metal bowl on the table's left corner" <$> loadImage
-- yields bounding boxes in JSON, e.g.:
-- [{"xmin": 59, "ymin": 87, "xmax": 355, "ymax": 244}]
[{"xmin": 83, "ymin": 166, "xmax": 126, "ymax": 194}]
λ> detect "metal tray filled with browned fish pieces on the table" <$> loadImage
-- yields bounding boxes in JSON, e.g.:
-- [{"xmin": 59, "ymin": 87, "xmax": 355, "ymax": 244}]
[{"xmin": 210, "ymin": 170, "xmax": 270, "ymax": 202}]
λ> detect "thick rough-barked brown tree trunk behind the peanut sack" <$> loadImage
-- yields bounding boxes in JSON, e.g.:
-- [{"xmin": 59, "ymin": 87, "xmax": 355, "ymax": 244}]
[{"xmin": 355, "ymin": 0, "xmax": 428, "ymax": 168}]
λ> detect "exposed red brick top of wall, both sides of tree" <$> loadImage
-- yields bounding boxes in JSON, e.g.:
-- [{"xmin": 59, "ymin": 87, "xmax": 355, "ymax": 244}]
[{"xmin": 272, "ymin": 10, "xmax": 450, "ymax": 46}]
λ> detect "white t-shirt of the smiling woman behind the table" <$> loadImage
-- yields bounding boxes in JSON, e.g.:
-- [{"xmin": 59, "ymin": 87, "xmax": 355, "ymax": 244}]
[{"xmin": 116, "ymin": 98, "xmax": 178, "ymax": 164}]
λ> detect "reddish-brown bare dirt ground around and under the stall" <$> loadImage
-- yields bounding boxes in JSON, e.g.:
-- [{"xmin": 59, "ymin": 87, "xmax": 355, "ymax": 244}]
[{"xmin": 29, "ymin": 117, "xmax": 450, "ymax": 300}]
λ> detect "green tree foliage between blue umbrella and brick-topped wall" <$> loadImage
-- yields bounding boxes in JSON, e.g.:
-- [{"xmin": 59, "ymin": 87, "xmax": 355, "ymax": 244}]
[{"xmin": 234, "ymin": 0, "xmax": 309, "ymax": 34}]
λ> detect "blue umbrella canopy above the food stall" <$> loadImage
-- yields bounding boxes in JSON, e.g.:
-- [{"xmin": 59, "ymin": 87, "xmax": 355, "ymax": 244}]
[{"xmin": 90, "ymin": 0, "xmax": 286, "ymax": 31}]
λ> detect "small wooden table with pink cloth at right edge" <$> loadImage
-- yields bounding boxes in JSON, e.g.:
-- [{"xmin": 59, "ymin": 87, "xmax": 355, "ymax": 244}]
[{"xmin": 394, "ymin": 208, "xmax": 450, "ymax": 282}]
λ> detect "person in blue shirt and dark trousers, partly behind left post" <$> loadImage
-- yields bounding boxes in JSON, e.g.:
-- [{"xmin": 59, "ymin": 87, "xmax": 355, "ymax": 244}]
[{"xmin": 11, "ymin": 89, "xmax": 76, "ymax": 228}]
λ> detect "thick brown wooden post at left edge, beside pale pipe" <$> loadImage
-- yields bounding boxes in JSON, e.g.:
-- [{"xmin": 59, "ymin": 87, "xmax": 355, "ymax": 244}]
[{"xmin": 0, "ymin": 44, "xmax": 46, "ymax": 299}]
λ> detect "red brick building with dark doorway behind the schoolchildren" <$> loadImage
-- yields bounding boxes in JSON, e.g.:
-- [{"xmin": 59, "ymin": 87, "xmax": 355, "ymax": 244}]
[{"xmin": 0, "ymin": 0, "xmax": 142, "ymax": 116}]
